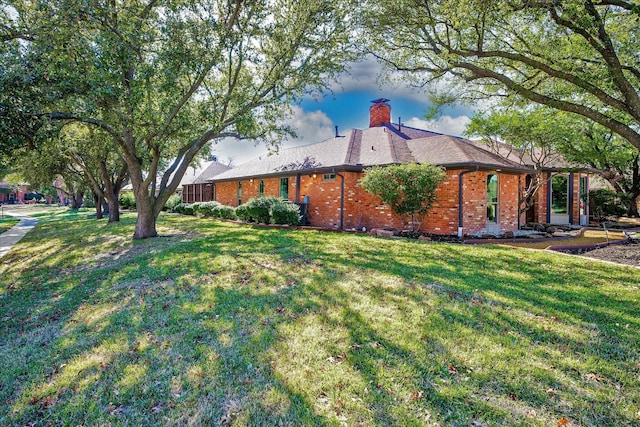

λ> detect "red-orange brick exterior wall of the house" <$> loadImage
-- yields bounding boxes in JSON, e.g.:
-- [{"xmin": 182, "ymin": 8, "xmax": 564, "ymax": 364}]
[{"xmin": 210, "ymin": 170, "xmax": 518, "ymax": 234}]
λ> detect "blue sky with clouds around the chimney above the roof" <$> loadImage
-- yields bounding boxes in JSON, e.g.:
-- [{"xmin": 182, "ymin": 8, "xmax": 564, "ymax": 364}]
[{"xmin": 213, "ymin": 59, "xmax": 474, "ymax": 166}]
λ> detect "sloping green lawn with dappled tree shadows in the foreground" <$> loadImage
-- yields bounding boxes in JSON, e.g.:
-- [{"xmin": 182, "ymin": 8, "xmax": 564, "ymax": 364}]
[{"xmin": 0, "ymin": 214, "xmax": 640, "ymax": 426}]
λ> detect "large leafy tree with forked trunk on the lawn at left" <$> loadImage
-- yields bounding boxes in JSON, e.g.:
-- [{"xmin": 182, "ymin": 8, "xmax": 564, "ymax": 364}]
[{"xmin": 0, "ymin": 0, "xmax": 352, "ymax": 238}]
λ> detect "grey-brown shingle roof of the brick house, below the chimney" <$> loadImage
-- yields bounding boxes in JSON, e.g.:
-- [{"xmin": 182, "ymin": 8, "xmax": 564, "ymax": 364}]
[{"xmin": 213, "ymin": 123, "xmax": 528, "ymax": 181}]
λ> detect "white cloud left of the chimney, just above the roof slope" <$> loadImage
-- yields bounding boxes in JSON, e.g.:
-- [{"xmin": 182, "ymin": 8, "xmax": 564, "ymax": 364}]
[{"xmin": 212, "ymin": 106, "xmax": 335, "ymax": 165}]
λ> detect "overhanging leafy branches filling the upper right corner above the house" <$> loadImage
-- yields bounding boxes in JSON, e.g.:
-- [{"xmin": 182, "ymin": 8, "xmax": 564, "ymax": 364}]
[{"xmin": 362, "ymin": 0, "xmax": 640, "ymax": 149}]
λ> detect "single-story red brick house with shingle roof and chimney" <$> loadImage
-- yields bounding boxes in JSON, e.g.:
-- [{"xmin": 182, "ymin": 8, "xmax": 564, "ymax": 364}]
[{"xmin": 203, "ymin": 99, "xmax": 592, "ymax": 235}]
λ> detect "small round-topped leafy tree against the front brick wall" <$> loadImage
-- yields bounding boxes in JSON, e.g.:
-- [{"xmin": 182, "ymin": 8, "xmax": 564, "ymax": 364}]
[{"xmin": 360, "ymin": 163, "xmax": 446, "ymax": 230}]
